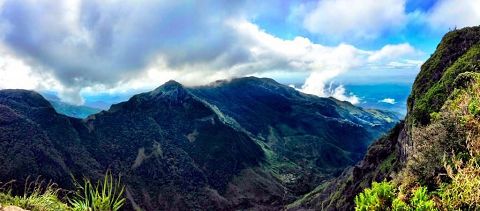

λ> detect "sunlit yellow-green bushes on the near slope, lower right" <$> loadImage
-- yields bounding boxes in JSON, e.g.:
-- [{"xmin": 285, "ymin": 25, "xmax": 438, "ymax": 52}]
[{"xmin": 355, "ymin": 72, "xmax": 480, "ymax": 210}]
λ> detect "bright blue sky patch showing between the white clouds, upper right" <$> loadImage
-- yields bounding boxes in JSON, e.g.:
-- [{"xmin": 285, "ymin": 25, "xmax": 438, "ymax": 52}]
[{"xmin": 252, "ymin": 0, "xmax": 442, "ymax": 52}]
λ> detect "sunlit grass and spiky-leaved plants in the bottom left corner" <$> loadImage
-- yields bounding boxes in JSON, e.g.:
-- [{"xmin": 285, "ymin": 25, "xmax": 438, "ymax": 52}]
[{"xmin": 0, "ymin": 172, "xmax": 125, "ymax": 211}]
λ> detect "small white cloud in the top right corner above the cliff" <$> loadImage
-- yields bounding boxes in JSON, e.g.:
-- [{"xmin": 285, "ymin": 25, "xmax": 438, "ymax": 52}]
[{"xmin": 426, "ymin": 0, "xmax": 480, "ymax": 30}]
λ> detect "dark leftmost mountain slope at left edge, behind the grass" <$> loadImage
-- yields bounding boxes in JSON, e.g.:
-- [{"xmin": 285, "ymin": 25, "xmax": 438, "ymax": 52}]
[{"xmin": 0, "ymin": 90, "xmax": 99, "ymax": 185}]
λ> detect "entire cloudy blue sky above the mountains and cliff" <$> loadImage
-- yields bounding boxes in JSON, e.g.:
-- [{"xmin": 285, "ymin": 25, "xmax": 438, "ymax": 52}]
[{"xmin": 0, "ymin": 0, "xmax": 480, "ymax": 105}]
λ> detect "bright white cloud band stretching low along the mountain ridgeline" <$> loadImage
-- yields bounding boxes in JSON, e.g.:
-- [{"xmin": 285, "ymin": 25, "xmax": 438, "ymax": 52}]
[{"xmin": 0, "ymin": 17, "xmax": 415, "ymax": 104}]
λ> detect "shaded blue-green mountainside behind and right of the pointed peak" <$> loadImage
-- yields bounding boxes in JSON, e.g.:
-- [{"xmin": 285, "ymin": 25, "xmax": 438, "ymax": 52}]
[{"xmin": 189, "ymin": 77, "xmax": 397, "ymax": 193}]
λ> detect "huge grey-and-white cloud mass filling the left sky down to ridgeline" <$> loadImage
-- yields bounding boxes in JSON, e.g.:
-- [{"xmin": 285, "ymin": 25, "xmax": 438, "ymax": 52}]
[{"xmin": 0, "ymin": 0, "xmax": 418, "ymax": 104}]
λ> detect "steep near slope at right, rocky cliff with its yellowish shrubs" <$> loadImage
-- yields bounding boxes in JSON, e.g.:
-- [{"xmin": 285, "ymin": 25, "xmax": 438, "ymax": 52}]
[{"xmin": 289, "ymin": 27, "xmax": 480, "ymax": 210}]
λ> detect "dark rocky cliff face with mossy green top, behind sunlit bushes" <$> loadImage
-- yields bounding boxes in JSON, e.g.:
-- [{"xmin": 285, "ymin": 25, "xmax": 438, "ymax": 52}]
[{"xmin": 288, "ymin": 27, "xmax": 480, "ymax": 210}]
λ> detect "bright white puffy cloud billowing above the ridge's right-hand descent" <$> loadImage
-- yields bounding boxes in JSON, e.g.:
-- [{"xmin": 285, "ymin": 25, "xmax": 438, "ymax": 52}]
[{"xmin": 301, "ymin": 43, "xmax": 422, "ymax": 104}]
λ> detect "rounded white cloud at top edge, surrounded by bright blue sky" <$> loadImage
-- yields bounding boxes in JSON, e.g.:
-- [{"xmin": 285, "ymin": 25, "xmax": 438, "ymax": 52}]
[{"xmin": 303, "ymin": 0, "xmax": 407, "ymax": 38}]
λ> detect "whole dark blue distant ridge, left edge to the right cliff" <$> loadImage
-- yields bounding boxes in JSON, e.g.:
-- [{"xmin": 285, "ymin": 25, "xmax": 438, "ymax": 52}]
[{"xmin": 0, "ymin": 77, "xmax": 398, "ymax": 210}]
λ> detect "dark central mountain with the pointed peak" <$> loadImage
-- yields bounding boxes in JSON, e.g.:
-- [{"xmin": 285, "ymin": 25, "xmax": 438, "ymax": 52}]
[{"xmin": 86, "ymin": 81, "xmax": 264, "ymax": 210}]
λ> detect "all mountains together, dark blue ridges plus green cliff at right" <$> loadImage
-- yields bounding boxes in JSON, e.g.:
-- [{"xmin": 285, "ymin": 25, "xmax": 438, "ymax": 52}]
[{"xmin": 0, "ymin": 27, "xmax": 480, "ymax": 210}]
